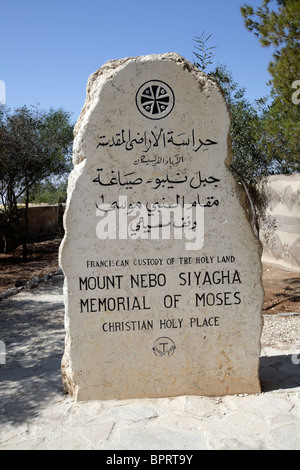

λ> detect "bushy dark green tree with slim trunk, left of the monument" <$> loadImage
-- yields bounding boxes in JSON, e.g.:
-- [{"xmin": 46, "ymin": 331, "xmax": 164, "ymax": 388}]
[{"xmin": 0, "ymin": 106, "xmax": 73, "ymax": 261}]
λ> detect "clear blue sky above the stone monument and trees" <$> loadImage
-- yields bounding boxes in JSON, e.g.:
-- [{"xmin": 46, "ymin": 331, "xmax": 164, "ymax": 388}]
[{"xmin": 0, "ymin": 0, "xmax": 272, "ymax": 121}]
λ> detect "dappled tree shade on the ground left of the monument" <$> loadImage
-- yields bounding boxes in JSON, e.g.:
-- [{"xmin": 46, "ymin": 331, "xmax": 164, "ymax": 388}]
[{"xmin": 0, "ymin": 276, "xmax": 65, "ymax": 424}]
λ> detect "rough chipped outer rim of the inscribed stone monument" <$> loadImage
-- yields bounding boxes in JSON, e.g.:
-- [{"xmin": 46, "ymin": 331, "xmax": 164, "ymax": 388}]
[{"xmin": 59, "ymin": 52, "xmax": 265, "ymax": 397}]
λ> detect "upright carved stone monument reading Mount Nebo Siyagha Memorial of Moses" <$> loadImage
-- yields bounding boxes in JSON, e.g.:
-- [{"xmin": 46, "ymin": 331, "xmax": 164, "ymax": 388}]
[{"xmin": 60, "ymin": 53, "xmax": 264, "ymax": 400}]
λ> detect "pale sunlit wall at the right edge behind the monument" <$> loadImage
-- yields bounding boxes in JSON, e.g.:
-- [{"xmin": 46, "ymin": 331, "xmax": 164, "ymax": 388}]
[{"xmin": 260, "ymin": 174, "xmax": 300, "ymax": 272}]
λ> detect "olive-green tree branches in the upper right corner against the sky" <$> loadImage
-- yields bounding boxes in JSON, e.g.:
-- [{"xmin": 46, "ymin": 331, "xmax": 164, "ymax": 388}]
[{"xmin": 241, "ymin": 0, "xmax": 300, "ymax": 173}]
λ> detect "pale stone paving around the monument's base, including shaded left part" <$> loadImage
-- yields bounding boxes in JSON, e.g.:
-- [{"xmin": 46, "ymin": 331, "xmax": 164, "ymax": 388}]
[{"xmin": 0, "ymin": 276, "xmax": 300, "ymax": 451}]
